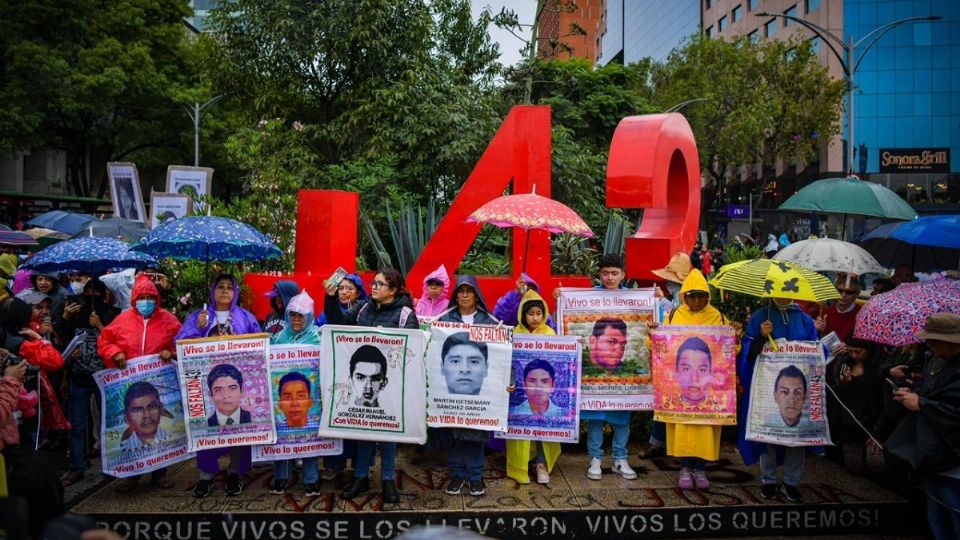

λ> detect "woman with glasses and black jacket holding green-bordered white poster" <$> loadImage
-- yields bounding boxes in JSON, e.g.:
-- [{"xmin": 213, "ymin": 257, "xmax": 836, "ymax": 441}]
[{"xmin": 323, "ymin": 268, "xmax": 420, "ymax": 503}]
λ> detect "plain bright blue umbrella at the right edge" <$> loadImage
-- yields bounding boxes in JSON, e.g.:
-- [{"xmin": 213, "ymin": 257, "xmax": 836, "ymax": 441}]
[{"xmin": 857, "ymin": 214, "xmax": 960, "ymax": 271}]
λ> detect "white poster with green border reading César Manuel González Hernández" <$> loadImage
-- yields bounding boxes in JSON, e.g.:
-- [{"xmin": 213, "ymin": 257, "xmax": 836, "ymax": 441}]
[{"xmin": 319, "ymin": 324, "xmax": 427, "ymax": 444}]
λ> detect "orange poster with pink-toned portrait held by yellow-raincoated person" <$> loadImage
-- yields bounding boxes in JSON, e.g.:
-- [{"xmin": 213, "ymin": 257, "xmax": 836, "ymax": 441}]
[{"xmin": 650, "ymin": 326, "xmax": 737, "ymax": 426}]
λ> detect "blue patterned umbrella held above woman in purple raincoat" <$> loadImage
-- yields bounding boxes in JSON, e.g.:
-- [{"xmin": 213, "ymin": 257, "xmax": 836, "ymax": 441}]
[{"xmin": 132, "ymin": 216, "xmax": 283, "ymax": 262}]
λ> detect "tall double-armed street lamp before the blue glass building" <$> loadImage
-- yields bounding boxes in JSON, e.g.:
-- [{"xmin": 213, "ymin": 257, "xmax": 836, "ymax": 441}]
[{"xmin": 757, "ymin": 11, "xmax": 943, "ymax": 172}]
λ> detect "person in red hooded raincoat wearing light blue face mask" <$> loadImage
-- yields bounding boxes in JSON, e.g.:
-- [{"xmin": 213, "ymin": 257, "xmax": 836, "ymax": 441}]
[{"xmin": 97, "ymin": 276, "xmax": 180, "ymax": 493}]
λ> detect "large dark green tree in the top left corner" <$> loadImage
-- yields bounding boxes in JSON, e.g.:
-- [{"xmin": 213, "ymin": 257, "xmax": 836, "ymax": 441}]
[{"xmin": 0, "ymin": 0, "xmax": 196, "ymax": 196}]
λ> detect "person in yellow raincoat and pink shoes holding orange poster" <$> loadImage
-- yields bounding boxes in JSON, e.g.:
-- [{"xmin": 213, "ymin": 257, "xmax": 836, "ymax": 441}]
[{"xmin": 648, "ymin": 269, "xmax": 730, "ymax": 489}]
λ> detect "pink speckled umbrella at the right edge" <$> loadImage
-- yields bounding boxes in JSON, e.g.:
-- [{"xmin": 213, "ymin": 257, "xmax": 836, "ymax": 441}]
[{"xmin": 856, "ymin": 277, "xmax": 960, "ymax": 347}]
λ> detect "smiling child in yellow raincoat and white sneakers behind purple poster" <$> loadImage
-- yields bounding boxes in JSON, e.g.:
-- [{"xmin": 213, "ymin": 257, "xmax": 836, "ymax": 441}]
[{"xmin": 507, "ymin": 289, "xmax": 560, "ymax": 484}]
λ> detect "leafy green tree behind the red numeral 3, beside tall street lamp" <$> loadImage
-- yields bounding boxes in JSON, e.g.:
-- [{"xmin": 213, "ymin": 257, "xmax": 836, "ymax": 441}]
[{"xmin": 651, "ymin": 35, "xmax": 843, "ymax": 207}]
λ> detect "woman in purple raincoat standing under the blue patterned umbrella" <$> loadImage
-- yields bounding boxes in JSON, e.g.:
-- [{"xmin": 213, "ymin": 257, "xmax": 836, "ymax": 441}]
[{"xmin": 177, "ymin": 274, "xmax": 260, "ymax": 498}]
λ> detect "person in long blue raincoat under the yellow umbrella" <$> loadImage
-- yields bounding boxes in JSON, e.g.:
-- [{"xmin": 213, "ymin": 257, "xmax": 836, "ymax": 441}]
[{"xmin": 737, "ymin": 298, "xmax": 820, "ymax": 503}]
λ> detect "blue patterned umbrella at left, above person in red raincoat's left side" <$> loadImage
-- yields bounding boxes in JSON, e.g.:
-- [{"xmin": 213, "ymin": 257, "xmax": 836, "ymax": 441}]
[{"xmin": 21, "ymin": 236, "xmax": 157, "ymax": 274}]
